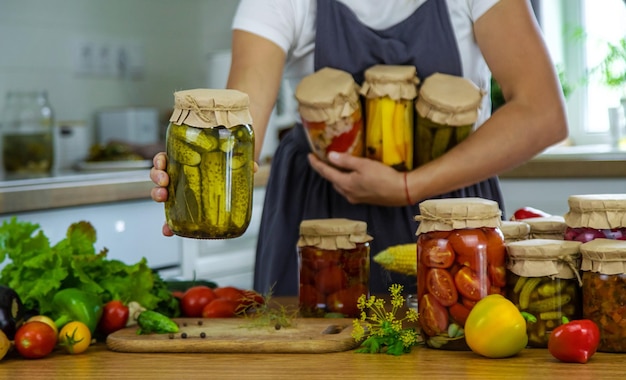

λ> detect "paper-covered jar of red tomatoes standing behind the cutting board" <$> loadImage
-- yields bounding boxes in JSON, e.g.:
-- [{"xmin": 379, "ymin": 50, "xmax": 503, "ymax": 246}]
[{"xmin": 298, "ymin": 219, "xmax": 372, "ymax": 318}]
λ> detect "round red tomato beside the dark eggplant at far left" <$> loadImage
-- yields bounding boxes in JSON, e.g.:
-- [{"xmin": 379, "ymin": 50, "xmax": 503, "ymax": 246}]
[{"xmin": 14, "ymin": 321, "xmax": 57, "ymax": 359}]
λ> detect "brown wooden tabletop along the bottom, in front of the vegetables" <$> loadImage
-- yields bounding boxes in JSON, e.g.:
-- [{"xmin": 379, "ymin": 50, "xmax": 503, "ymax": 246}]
[{"xmin": 0, "ymin": 344, "xmax": 626, "ymax": 380}]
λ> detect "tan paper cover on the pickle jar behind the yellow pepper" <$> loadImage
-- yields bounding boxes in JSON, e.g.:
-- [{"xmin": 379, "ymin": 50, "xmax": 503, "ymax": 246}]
[{"xmin": 506, "ymin": 239, "xmax": 582, "ymax": 286}]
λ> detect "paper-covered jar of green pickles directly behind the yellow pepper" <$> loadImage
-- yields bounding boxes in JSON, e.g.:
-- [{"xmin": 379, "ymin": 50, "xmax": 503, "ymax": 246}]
[{"xmin": 506, "ymin": 239, "xmax": 582, "ymax": 347}]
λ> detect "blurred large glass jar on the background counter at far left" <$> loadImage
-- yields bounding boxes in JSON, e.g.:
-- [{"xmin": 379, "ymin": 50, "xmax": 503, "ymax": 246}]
[{"xmin": 2, "ymin": 91, "xmax": 54, "ymax": 177}]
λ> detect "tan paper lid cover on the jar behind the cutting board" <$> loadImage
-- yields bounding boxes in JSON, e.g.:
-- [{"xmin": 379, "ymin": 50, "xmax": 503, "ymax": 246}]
[{"xmin": 297, "ymin": 218, "xmax": 373, "ymax": 250}]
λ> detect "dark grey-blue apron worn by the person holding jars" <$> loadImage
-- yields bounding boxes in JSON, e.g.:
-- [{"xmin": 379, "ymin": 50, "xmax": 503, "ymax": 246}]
[{"xmin": 254, "ymin": 0, "xmax": 504, "ymax": 296}]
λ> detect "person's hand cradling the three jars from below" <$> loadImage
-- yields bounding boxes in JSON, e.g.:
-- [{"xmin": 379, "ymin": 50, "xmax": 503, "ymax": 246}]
[{"xmin": 309, "ymin": 152, "xmax": 407, "ymax": 206}]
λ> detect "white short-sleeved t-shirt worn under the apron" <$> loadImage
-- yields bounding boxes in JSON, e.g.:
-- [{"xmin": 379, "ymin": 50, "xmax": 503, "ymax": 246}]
[{"xmin": 232, "ymin": 0, "xmax": 499, "ymax": 125}]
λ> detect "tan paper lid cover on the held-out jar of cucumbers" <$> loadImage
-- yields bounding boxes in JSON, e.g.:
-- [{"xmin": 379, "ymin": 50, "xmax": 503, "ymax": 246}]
[{"xmin": 169, "ymin": 88, "xmax": 252, "ymax": 128}]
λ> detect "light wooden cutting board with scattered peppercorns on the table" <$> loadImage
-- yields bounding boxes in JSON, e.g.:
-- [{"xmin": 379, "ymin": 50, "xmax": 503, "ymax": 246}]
[{"xmin": 106, "ymin": 318, "xmax": 359, "ymax": 353}]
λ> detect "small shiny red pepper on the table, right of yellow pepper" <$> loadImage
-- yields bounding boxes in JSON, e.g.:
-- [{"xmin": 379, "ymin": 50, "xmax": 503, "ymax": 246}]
[{"xmin": 548, "ymin": 319, "xmax": 600, "ymax": 364}]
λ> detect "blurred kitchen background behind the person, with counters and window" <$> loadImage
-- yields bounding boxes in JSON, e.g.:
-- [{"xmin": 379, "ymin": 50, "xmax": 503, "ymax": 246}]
[{"xmin": 0, "ymin": 0, "xmax": 626, "ymax": 287}]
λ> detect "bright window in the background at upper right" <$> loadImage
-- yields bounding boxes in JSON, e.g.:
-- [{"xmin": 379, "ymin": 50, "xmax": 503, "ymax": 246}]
[{"xmin": 535, "ymin": 0, "xmax": 626, "ymax": 145}]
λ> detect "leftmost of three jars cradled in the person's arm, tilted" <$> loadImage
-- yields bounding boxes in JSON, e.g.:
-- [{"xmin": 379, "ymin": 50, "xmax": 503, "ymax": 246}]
[{"xmin": 295, "ymin": 67, "xmax": 364, "ymax": 161}]
